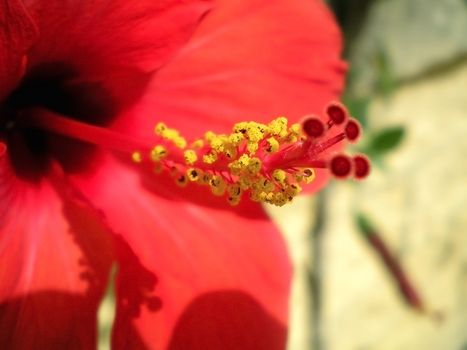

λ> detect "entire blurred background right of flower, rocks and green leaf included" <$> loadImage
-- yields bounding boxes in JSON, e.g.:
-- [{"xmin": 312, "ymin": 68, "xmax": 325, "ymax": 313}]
[{"xmin": 272, "ymin": 0, "xmax": 467, "ymax": 350}]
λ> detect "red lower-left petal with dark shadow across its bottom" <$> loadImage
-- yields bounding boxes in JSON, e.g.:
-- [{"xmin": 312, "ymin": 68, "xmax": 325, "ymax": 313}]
[{"xmin": 0, "ymin": 152, "xmax": 112, "ymax": 349}]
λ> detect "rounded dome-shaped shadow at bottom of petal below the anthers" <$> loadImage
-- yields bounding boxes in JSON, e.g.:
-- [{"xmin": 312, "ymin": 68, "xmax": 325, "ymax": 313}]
[{"xmin": 169, "ymin": 291, "xmax": 286, "ymax": 350}]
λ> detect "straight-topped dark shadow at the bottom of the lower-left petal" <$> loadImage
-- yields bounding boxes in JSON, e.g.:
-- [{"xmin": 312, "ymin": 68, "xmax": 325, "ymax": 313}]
[{"xmin": 0, "ymin": 291, "xmax": 97, "ymax": 350}]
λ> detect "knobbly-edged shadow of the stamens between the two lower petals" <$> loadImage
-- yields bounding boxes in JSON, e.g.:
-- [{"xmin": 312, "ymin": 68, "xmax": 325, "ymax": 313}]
[{"xmin": 52, "ymin": 163, "xmax": 162, "ymax": 317}]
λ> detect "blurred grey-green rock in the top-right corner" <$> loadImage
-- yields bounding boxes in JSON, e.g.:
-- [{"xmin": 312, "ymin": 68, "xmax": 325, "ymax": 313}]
[{"xmin": 345, "ymin": 0, "xmax": 467, "ymax": 93}]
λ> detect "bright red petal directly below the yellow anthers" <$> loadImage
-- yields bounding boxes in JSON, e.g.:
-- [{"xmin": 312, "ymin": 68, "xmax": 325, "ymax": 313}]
[{"xmin": 71, "ymin": 159, "xmax": 290, "ymax": 349}]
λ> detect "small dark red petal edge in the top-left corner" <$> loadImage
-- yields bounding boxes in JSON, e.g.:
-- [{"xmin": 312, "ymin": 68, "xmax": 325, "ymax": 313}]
[{"xmin": 0, "ymin": 0, "xmax": 37, "ymax": 101}]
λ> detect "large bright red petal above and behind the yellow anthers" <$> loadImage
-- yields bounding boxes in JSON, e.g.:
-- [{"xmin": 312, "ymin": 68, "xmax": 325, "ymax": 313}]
[{"xmin": 114, "ymin": 0, "xmax": 345, "ymax": 137}]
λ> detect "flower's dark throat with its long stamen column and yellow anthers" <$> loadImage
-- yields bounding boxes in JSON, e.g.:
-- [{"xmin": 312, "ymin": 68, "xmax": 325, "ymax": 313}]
[{"xmin": 3, "ymin": 67, "xmax": 370, "ymax": 206}]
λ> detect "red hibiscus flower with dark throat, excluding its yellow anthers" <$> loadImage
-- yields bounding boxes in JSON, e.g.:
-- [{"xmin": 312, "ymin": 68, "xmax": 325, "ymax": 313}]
[{"xmin": 0, "ymin": 0, "xmax": 366, "ymax": 349}]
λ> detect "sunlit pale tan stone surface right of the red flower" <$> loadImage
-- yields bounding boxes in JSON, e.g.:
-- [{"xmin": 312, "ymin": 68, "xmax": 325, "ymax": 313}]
[{"xmin": 274, "ymin": 60, "xmax": 467, "ymax": 350}]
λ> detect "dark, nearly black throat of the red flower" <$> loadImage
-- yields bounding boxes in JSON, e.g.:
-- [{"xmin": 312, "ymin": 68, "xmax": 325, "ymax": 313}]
[{"xmin": 0, "ymin": 63, "xmax": 115, "ymax": 180}]
